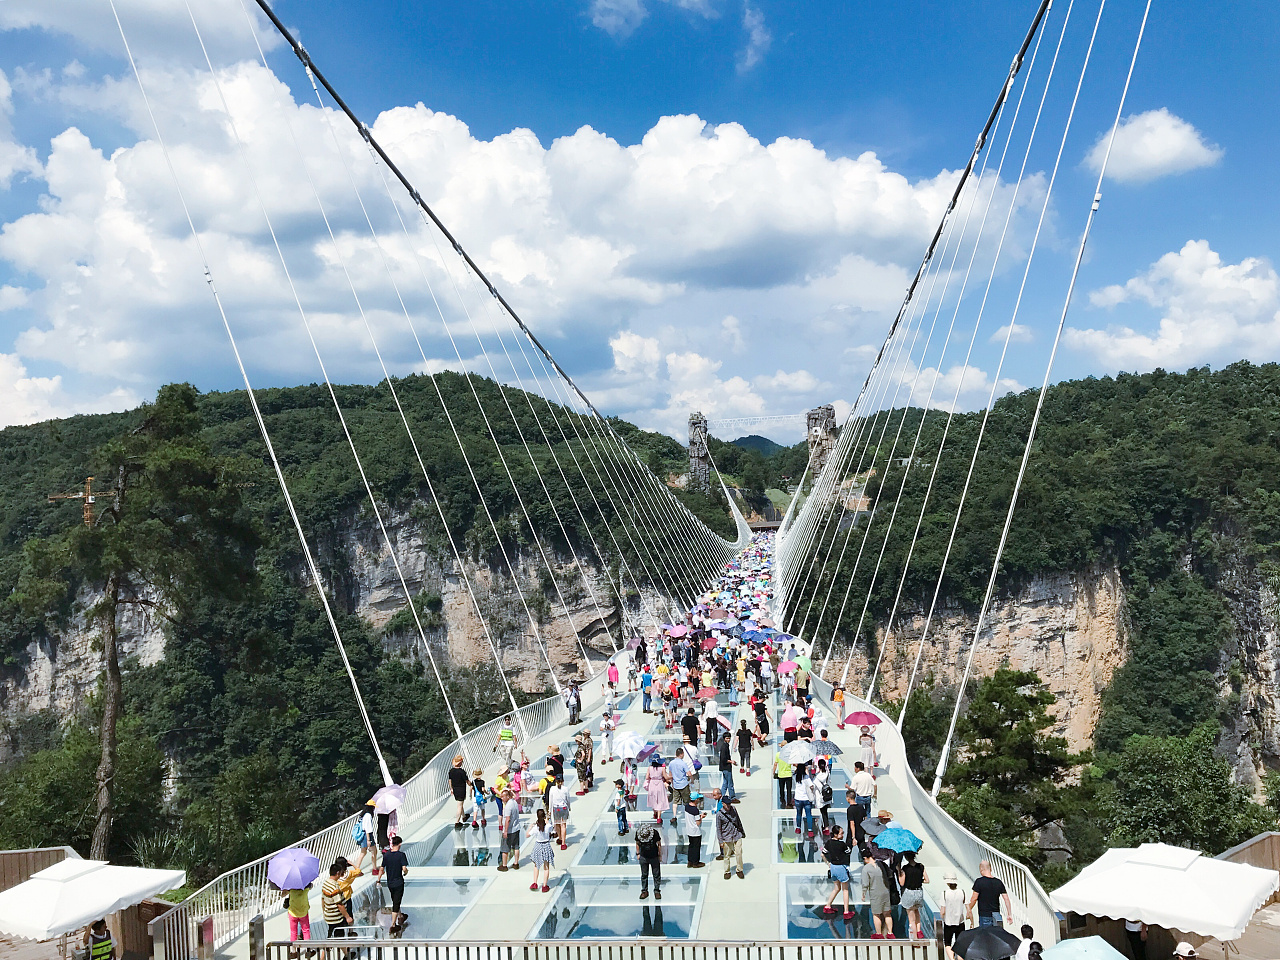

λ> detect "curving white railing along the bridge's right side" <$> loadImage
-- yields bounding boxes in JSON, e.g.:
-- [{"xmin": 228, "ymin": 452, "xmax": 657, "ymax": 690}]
[{"xmin": 812, "ymin": 677, "xmax": 1057, "ymax": 943}]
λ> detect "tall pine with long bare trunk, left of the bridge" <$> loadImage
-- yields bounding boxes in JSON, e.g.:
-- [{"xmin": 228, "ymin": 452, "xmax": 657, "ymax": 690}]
[{"xmin": 65, "ymin": 384, "xmax": 257, "ymax": 859}]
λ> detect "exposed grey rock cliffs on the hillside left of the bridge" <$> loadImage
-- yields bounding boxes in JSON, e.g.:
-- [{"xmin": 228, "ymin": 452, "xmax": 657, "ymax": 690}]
[{"xmin": 0, "ymin": 513, "xmax": 640, "ymax": 749}]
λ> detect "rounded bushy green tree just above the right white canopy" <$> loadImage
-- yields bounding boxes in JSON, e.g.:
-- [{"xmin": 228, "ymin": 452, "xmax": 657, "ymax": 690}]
[{"xmin": 1107, "ymin": 723, "xmax": 1276, "ymax": 854}]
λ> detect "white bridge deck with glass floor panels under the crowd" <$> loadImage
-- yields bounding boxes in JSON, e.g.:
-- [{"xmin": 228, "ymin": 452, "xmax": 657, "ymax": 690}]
[{"xmin": 218, "ymin": 694, "xmax": 970, "ymax": 960}]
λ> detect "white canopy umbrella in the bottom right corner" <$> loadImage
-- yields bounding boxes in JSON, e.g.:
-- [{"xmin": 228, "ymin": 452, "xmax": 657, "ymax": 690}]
[{"xmin": 1050, "ymin": 844, "xmax": 1280, "ymax": 941}]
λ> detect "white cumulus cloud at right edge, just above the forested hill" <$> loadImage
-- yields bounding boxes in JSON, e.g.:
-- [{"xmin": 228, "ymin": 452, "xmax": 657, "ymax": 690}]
[{"xmin": 1065, "ymin": 239, "xmax": 1280, "ymax": 370}]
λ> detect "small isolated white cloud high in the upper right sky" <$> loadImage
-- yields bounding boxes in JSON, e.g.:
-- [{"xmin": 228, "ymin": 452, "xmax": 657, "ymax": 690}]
[{"xmin": 1084, "ymin": 108, "xmax": 1224, "ymax": 183}]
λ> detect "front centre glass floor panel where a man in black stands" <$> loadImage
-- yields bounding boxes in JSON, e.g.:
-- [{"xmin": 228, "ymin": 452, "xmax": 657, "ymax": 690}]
[{"xmin": 530, "ymin": 876, "xmax": 703, "ymax": 940}]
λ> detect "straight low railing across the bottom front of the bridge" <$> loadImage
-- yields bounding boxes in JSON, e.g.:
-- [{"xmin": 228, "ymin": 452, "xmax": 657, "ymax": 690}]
[{"xmin": 266, "ymin": 938, "xmax": 938, "ymax": 960}]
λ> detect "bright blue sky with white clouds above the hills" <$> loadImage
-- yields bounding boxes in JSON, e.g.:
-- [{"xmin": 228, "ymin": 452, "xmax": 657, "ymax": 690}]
[{"xmin": 0, "ymin": 0, "xmax": 1280, "ymax": 439}]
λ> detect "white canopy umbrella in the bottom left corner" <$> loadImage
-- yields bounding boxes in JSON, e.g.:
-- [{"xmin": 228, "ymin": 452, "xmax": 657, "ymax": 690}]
[{"xmin": 0, "ymin": 859, "xmax": 187, "ymax": 940}]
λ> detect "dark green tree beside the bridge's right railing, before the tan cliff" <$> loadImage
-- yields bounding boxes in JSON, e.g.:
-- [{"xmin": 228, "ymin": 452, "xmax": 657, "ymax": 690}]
[{"xmin": 943, "ymin": 667, "xmax": 1088, "ymax": 865}]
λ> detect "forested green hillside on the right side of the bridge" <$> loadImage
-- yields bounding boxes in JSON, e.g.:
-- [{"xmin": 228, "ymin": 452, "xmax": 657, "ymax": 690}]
[{"xmin": 783, "ymin": 362, "xmax": 1280, "ymax": 879}]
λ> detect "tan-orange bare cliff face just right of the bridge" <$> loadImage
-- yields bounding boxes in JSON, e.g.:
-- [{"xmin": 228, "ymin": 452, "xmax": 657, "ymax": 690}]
[{"xmin": 827, "ymin": 568, "xmax": 1125, "ymax": 750}]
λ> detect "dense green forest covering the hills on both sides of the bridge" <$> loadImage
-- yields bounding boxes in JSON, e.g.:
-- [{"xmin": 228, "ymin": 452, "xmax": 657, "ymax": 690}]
[{"xmin": 0, "ymin": 364, "xmax": 1280, "ymax": 879}]
